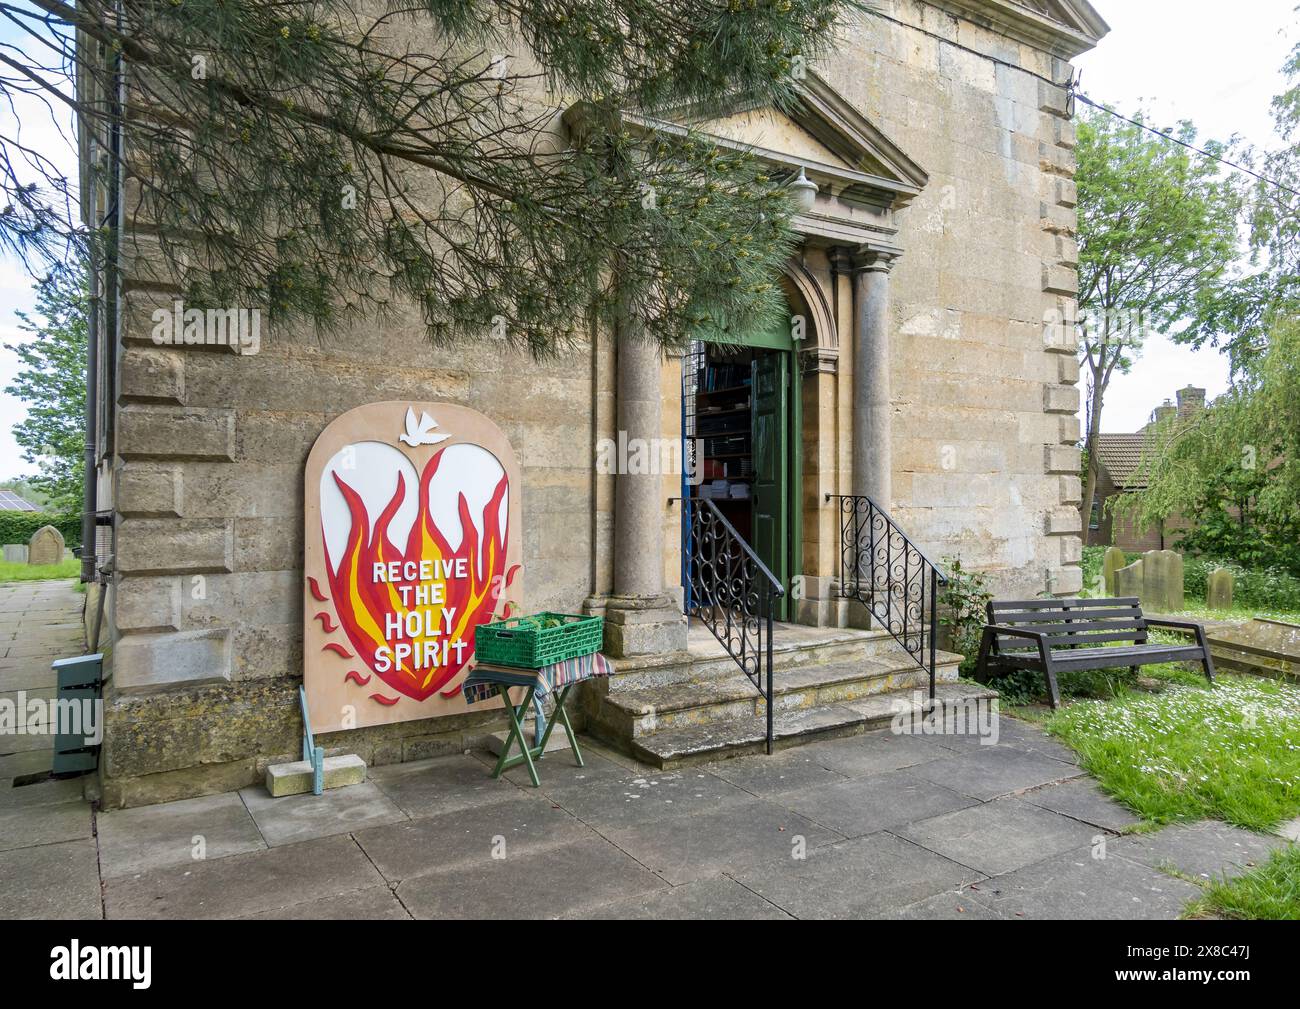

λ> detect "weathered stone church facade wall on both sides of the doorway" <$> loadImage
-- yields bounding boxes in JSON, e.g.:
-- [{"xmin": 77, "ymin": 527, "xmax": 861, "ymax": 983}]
[{"xmin": 86, "ymin": 0, "xmax": 1105, "ymax": 805}]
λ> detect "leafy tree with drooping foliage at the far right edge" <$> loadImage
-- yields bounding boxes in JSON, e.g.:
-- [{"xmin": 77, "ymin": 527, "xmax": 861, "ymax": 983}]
[{"xmin": 1121, "ymin": 35, "xmax": 1300, "ymax": 573}]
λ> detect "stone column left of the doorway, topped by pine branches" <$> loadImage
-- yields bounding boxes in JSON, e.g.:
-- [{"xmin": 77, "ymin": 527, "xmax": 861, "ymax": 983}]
[{"xmin": 605, "ymin": 320, "xmax": 686, "ymax": 657}]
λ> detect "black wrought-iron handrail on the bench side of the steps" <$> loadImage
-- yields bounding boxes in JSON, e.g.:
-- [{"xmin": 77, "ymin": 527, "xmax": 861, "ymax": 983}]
[{"xmin": 826, "ymin": 494, "xmax": 948, "ymax": 701}]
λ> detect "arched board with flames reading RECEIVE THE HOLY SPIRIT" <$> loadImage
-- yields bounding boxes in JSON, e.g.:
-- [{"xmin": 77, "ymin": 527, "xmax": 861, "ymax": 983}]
[{"xmin": 303, "ymin": 402, "xmax": 523, "ymax": 732}]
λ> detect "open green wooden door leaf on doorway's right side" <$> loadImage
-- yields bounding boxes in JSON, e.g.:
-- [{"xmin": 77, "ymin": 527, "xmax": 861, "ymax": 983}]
[{"xmin": 751, "ymin": 354, "xmax": 792, "ymax": 620}]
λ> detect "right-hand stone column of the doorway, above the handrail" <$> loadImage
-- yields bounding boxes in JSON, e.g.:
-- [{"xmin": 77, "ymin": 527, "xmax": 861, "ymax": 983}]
[{"xmin": 853, "ymin": 251, "xmax": 897, "ymax": 511}]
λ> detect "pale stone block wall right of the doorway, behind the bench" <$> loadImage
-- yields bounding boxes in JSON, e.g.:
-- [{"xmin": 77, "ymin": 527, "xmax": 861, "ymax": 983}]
[{"xmin": 823, "ymin": 0, "xmax": 1082, "ymax": 596}]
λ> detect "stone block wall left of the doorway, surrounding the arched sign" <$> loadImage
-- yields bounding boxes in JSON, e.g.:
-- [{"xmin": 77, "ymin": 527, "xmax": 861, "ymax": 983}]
[{"xmin": 101, "ymin": 282, "xmax": 595, "ymax": 805}]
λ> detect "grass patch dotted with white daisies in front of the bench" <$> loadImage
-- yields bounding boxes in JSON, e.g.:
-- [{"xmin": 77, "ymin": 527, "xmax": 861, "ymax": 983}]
[{"xmin": 1044, "ymin": 666, "xmax": 1300, "ymax": 831}]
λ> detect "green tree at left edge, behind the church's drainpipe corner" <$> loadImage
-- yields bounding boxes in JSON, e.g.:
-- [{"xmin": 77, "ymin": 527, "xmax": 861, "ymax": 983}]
[{"xmin": 5, "ymin": 269, "xmax": 90, "ymax": 511}]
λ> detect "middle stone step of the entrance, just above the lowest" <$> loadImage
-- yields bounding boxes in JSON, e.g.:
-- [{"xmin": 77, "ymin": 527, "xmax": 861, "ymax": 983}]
[{"xmin": 589, "ymin": 650, "xmax": 961, "ymax": 740}]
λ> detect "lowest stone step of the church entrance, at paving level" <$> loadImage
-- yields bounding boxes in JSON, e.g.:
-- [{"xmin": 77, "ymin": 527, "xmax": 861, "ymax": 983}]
[{"xmin": 631, "ymin": 683, "xmax": 997, "ymax": 770}]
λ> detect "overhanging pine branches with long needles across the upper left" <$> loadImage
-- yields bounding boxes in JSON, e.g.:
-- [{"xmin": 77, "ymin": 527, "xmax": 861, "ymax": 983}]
[{"xmin": 10, "ymin": 0, "xmax": 858, "ymax": 354}]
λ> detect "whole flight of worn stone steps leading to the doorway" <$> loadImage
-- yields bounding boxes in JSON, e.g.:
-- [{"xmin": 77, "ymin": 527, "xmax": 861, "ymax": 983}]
[{"xmin": 584, "ymin": 624, "xmax": 992, "ymax": 768}]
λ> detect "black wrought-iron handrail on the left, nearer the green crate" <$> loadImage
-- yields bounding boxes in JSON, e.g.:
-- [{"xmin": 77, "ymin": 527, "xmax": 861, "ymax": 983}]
[{"xmin": 673, "ymin": 498, "xmax": 785, "ymax": 753}]
